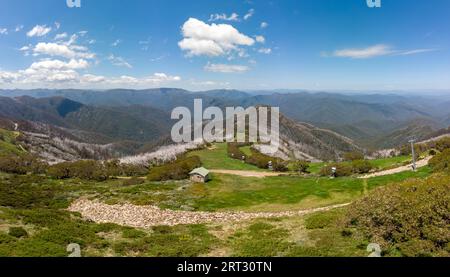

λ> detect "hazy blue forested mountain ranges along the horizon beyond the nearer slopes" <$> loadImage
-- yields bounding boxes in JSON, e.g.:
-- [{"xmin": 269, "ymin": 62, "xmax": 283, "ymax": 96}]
[{"xmin": 0, "ymin": 88, "xmax": 450, "ymax": 159}]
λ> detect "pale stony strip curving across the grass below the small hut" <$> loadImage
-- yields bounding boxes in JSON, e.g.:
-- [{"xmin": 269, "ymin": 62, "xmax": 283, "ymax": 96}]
[{"xmin": 69, "ymin": 199, "xmax": 350, "ymax": 228}]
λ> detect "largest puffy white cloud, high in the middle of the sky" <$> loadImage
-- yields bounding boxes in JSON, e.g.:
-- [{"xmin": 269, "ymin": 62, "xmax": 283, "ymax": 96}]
[{"xmin": 178, "ymin": 18, "xmax": 255, "ymax": 56}]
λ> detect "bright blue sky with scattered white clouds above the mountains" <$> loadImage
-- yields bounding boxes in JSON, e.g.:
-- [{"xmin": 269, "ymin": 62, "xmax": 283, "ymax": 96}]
[{"xmin": 0, "ymin": 0, "xmax": 450, "ymax": 90}]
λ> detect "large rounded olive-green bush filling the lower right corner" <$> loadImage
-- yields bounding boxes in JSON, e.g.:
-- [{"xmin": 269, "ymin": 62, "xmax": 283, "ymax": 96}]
[{"xmin": 345, "ymin": 175, "xmax": 450, "ymax": 256}]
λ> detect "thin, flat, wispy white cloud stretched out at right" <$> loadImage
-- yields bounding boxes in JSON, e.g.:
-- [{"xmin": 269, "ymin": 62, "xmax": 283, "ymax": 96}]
[{"xmin": 323, "ymin": 44, "xmax": 436, "ymax": 59}]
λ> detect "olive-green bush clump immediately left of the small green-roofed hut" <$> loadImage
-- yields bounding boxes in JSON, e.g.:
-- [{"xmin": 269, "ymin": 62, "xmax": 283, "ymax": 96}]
[{"xmin": 147, "ymin": 156, "xmax": 202, "ymax": 181}]
